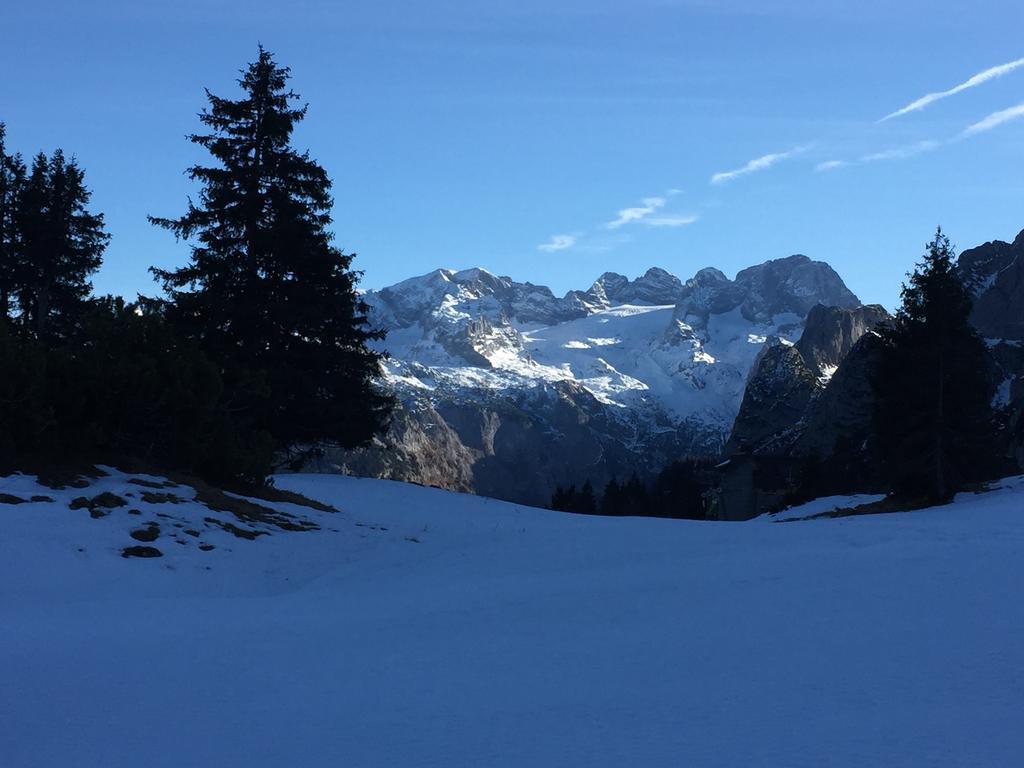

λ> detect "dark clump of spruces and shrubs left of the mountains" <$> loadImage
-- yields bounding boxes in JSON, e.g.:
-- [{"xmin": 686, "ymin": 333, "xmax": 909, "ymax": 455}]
[{"xmin": 0, "ymin": 47, "xmax": 391, "ymax": 481}]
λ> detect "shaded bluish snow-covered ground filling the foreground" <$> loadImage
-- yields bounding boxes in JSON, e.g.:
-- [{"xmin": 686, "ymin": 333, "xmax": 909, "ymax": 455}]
[{"xmin": 0, "ymin": 472, "xmax": 1024, "ymax": 768}]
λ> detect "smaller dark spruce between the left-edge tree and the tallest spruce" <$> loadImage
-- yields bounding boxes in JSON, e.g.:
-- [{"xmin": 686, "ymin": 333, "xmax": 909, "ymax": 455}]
[{"xmin": 14, "ymin": 150, "xmax": 110, "ymax": 341}]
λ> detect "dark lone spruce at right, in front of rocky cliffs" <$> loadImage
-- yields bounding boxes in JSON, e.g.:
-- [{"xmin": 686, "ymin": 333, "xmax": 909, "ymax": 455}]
[{"xmin": 871, "ymin": 228, "xmax": 995, "ymax": 503}]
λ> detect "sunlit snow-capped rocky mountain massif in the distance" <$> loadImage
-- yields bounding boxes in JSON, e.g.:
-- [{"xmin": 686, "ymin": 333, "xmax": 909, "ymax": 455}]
[{"xmin": 315, "ymin": 256, "xmax": 860, "ymax": 504}]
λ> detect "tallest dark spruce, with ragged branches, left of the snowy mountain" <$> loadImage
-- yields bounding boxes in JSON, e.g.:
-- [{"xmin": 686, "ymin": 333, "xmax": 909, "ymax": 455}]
[{"xmin": 151, "ymin": 46, "xmax": 390, "ymax": 456}]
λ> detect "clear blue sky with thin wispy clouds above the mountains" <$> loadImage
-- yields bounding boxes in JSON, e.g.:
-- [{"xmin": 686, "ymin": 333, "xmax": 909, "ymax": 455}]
[{"xmin": 0, "ymin": 0, "xmax": 1024, "ymax": 307}]
